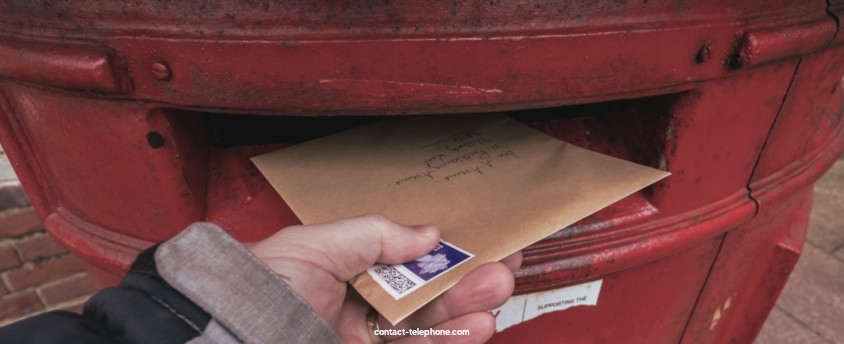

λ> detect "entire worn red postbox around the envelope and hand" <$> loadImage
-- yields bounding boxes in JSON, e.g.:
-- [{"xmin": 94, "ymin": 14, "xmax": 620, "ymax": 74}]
[{"xmin": 0, "ymin": 0, "xmax": 844, "ymax": 343}]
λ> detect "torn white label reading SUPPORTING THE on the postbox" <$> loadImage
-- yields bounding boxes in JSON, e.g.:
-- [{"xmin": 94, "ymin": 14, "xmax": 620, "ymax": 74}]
[{"xmin": 491, "ymin": 280, "xmax": 604, "ymax": 332}]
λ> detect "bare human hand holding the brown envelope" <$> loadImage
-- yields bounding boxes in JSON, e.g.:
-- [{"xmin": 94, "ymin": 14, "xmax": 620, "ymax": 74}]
[{"xmin": 249, "ymin": 214, "xmax": 521, "ymax": 343}]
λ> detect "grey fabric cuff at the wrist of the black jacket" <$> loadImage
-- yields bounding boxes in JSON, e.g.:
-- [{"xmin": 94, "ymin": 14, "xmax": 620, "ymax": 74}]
[{"xmin": 155, "ymin": 222, "xmax": 341, "ymax": 343}]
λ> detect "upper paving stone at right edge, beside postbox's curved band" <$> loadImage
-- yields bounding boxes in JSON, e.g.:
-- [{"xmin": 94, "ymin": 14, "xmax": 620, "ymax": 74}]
[{"xmin": 806, "ymin": 189, "xmax": 844, "ymax": 254}]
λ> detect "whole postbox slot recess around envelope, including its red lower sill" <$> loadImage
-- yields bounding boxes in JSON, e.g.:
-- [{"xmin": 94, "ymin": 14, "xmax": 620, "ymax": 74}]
[{"xmin": 150, "ymin": 93, "xmax": 683, "ymax": 242}]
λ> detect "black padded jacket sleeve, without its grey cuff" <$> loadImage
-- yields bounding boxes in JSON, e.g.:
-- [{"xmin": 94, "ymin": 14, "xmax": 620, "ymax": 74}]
[{"xmin": 0, "ymin": 245, "xmax": 211, "ymax": 343}]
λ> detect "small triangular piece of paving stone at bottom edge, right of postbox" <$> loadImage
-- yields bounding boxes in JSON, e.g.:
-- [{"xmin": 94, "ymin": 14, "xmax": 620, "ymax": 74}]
[{"xmin": 753, "ymin": 308, "xmax": 830, "ymax": 344}]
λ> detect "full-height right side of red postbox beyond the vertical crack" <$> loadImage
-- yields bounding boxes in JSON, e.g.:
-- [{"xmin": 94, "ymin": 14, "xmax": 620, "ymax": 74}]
[{"xmin": 684, "ymin": 47, "xmax": 844, "ymax": 343}]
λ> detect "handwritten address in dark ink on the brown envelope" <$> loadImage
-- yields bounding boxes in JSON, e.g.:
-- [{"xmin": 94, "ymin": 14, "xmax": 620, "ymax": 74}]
[{"xmin": 393, "ymin": 130, "xmax": 519, "ymax": 185}]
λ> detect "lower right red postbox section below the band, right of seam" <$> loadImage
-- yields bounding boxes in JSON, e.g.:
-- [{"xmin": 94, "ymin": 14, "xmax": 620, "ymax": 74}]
[{"xmin": 682, "ymin": 187, "xmax": 812, "ymax": 343}]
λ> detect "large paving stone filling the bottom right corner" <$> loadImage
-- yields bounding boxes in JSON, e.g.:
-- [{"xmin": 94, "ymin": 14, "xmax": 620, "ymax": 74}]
[{"xmin": 777, "ymin": 244, "xmax": 844, "ymax": 343}]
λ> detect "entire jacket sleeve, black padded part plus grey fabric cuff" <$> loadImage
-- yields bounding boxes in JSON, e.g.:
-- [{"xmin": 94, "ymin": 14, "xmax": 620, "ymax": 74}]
[{"xmin": 0, "ymin": 222, "xmax": 340, "ymax": 344}]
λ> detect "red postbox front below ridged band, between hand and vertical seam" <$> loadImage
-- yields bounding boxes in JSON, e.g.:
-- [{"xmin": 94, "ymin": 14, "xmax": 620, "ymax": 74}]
[{"xmin": 490, "ymin": 236, "xmax": 721, "ymax": 343}]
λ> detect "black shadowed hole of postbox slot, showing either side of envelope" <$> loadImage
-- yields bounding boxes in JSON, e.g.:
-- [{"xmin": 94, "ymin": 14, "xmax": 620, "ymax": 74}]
[{"xmin": 201, "ymin": 94, "xmax": 681, "ymax": 175}]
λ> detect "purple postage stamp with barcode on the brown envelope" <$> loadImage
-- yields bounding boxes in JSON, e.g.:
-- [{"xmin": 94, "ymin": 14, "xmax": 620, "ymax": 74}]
[{"xmin": 366, "ymin": 240, "xmax": 475, "ymax": 300}]
